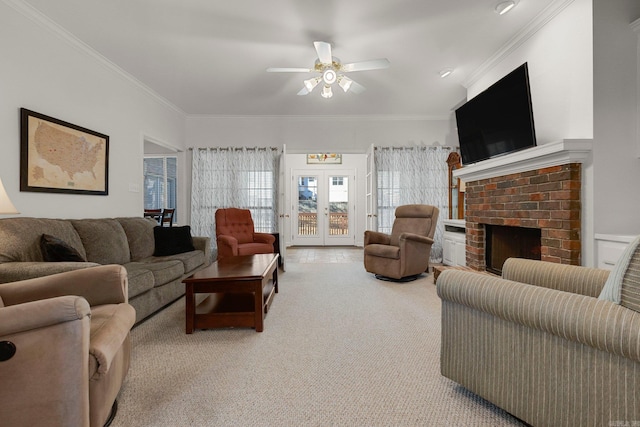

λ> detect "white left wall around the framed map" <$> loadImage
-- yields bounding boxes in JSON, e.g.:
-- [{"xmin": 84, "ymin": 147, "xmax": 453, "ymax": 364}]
[{"xmin": 0, "ymin": 2, "xmax": 186, "ymax": 218}]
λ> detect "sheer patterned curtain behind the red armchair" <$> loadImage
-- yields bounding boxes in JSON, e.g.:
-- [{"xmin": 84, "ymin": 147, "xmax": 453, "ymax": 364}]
[{"xmin": 191, "ymin": 147, "xmax": 280, "ymax": 254}]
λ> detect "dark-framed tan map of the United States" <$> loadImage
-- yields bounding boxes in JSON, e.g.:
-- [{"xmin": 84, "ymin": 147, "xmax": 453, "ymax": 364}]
[{"xmin": 20, "ymin": 108, "xmax": 109, "ymax": 196}]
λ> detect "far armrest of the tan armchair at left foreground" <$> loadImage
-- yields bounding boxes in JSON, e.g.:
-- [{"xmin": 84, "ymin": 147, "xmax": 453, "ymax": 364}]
[{"xmin": 0, "ymin": 264, "xmax": 128, "ymax": 306}]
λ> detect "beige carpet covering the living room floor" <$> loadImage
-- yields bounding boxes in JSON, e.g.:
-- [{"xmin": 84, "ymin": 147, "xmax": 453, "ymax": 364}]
[{"xmin": 112, "ymin": 263, "xmax": 522, "ymax": 427}]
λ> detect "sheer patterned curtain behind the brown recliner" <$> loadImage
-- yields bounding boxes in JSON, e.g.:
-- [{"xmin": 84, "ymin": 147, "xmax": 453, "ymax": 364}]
[{"xmin": 375, "ymin": 146, "xmax": 452, "ymax": 262}]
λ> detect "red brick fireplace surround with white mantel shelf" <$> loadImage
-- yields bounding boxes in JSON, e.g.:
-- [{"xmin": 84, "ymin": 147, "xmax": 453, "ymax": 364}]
[{"xmin": 458, "ymin": 140, "xmax": 590, "ymax": 271}]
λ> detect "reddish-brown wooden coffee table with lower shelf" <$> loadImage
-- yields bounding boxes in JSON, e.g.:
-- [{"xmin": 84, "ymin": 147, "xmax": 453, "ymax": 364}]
[{"xmin": 183, "ymin": 254, "xmax": 278, "ymax": 334}]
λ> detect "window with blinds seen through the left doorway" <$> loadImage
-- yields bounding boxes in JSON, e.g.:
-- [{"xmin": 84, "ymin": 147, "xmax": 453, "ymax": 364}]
[{"xmin": 144, "ymin": 157, "xmax": 178, "ymax": 221}]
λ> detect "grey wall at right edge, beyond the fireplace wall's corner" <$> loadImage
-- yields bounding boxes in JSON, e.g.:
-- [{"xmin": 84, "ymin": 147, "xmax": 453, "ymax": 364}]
[{"xmin": 593, "ymin": 0, "xmax": 640, "ymax": 234}]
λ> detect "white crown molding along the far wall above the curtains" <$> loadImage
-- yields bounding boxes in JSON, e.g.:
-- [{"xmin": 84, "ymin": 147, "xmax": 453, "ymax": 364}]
[{"xmin": 187, "ymin": 114, "xmax": 451, "ymax": 122}]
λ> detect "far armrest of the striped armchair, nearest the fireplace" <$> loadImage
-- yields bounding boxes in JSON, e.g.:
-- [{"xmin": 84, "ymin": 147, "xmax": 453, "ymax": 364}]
[{"xmin": 502, "ymin": 258, "xmax": 609, "ymax": 297}]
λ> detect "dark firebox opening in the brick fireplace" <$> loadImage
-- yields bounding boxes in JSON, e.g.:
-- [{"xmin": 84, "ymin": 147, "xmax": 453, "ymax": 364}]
[{"xmin": 485, "ymin": 224, "xmax": 542, "ymax": 274}]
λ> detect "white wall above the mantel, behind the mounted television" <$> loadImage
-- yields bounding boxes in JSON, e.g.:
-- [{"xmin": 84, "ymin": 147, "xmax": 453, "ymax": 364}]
[{"xmin": 467, "ymin": 0, "xmax": 593, "ymax": 145}]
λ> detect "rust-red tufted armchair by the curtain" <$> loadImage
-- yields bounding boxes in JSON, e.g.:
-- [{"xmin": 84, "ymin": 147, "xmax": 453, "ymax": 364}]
[{"xmin": 216, "ymin": 208, "xmax": 276, "ymax": 259}]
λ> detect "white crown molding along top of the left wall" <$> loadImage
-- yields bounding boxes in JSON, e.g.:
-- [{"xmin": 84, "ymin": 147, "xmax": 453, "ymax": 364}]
[{"xmin": 1, "ymin": 0, "xmax": 186, "ymax": 116}]
